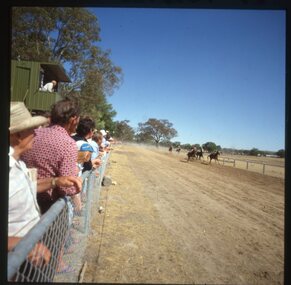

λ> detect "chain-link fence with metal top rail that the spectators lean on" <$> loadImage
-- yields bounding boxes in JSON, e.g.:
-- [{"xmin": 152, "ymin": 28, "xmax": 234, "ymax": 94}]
[{"xmin": 7, "ymin": 154, "xmax": 109, "ymax": 282}]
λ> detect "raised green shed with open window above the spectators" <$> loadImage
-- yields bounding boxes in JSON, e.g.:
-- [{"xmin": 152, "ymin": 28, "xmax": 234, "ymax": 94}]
[{"xmin": 11, "ymin": 60, "xmax": 71, "ymax": 111}]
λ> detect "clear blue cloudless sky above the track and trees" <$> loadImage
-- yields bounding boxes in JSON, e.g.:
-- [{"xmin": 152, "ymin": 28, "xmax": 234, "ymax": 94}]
[{"xmin": 90, "ymin": 8, "xmax": 285, "ymax": 151}]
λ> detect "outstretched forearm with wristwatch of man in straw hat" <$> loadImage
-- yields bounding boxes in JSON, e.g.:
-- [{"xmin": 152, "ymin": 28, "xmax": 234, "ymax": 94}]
[{"xmin": 37, "ymin": 176, "xmax": 82, "ymax": 193}]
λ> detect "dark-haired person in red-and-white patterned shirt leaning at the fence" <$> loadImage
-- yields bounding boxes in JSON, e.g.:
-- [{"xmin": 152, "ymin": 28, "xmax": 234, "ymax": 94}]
[{"xmin": 22, "ymin": 99, "xmax": 80, "ymax": 213}]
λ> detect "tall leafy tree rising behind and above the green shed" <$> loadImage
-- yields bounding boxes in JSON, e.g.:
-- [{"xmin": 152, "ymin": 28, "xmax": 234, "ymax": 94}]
[{"xmin": 11, "ymin": 7, "xmax": 122, "ymax": 125}]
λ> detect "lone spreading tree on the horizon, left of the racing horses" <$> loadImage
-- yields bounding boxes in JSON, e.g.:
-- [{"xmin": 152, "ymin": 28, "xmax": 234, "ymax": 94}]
[{"xmin": 138, "ymin": 118, "xmax": 178, "ymax": 145}]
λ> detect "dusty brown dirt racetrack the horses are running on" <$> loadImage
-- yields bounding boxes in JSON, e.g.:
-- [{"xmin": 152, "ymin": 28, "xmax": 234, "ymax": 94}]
[{"xmin": 84, "ymin": 145, "xmax": 284, "ymax": 284}]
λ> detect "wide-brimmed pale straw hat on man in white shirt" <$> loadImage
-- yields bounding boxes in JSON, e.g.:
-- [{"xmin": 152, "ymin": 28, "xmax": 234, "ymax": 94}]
[{"xmin": 9, "ymin": 102, "xmax": 48, "ymax": 134}]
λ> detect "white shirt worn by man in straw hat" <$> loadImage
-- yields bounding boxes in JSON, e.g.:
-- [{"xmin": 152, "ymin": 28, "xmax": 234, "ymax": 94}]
[{"xmin": 8, "ymin": 147, "xmax": 40, "ymax": 237}]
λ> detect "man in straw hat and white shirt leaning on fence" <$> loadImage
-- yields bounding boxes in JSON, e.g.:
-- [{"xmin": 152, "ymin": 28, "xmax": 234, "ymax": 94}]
[{"xmin": 8, "ymin": 102, "xmax": 81, "ymax": 272}]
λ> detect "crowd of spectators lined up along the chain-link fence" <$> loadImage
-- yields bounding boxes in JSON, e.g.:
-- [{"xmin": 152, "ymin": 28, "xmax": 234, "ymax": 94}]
[{"xmin": 8, "ymin": 99, "xmax": 110, "ymax": 278}]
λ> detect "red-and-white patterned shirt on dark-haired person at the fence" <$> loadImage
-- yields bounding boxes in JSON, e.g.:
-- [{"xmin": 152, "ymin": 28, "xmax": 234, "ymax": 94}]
[{"xmin": 21, "ymin": 125, "xmax": 78, "ymax": 202}]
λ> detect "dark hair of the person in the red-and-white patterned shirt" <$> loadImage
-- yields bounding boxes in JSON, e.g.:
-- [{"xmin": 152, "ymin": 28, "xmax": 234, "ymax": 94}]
[{"xmin": 51, "ymin": 98, "xmax": 81, "ymax": 126}]
